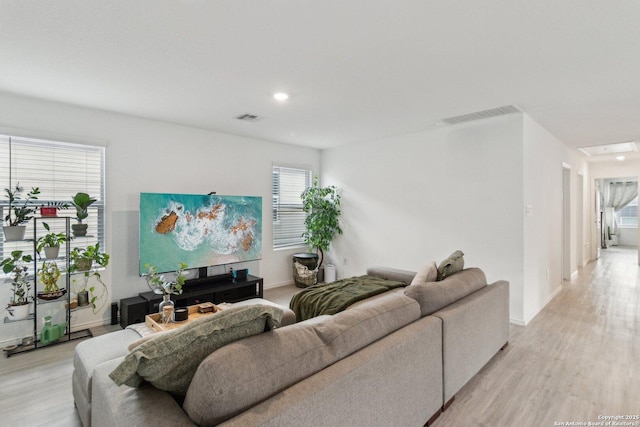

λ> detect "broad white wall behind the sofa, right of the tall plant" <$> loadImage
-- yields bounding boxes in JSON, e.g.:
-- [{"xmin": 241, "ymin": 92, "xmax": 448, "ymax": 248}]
[{"xmin": 321, "ymin": 115, "xmax": 523, "ymax": 319}]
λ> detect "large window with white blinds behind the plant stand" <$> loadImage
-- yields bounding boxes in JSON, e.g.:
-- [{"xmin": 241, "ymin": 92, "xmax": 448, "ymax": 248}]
[{"xmin": 0, "ymin": 135, "xmax": 104, "ymax": 259}]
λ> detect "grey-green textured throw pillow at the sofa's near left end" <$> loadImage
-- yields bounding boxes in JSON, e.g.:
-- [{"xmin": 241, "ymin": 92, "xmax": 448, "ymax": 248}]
[{"xmin": 109, "ymin": 304, "xmax": 284, "ymax": 396}]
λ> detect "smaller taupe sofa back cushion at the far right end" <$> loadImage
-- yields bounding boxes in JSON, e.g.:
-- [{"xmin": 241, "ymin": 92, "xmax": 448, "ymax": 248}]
[{"xmin": 404, "ymin": 268, "xmax": 487, "ymax": 316}]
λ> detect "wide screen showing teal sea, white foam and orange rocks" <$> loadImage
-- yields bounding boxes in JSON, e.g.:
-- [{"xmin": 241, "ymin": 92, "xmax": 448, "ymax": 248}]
[{"xmin": 140, "ymin": 193, "xmax": 262, "ymax": 274}]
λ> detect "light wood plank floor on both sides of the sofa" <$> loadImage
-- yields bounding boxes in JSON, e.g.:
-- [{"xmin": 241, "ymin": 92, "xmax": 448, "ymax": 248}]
[{"xmin": 0, "ymin": 247, "xmax": 640, "ymax": 427}]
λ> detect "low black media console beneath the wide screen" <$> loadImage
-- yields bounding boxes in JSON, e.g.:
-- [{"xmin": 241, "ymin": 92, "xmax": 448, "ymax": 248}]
[{"xmin": 120, "ymin": 274, "xmax": 264, "ymax": 328}]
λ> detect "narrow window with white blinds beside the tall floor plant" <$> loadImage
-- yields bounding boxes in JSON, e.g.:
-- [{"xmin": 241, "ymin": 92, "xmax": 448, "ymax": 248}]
[{"xmin": 272, "ymin": 166, "xmax": 312, "ymax": 249}]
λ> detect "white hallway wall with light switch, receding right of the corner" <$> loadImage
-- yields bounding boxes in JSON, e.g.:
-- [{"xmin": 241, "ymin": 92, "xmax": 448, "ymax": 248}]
[{"xmin": 522, "ymin": 114, "xmax": 589, "ymax": 324}]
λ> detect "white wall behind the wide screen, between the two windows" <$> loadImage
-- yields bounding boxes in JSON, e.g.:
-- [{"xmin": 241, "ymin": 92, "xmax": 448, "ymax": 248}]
[{"xmin": 0, "ymin": 93, "xmax": 320, "ymax": 340}]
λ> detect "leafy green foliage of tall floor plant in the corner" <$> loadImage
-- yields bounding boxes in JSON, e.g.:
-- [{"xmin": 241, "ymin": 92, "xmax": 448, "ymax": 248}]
[{"xmin": 301, "ymin": 176, "xmax": 342, "ymax": 266}]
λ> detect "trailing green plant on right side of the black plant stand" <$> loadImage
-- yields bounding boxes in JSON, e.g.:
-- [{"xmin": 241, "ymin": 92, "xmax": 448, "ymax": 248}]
[{"xmin": 70, "ymin": 243, "xmax": 109, "ymax": 313}]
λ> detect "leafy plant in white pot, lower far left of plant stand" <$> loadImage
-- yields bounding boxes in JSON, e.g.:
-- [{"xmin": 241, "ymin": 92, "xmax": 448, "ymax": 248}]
[{"xmin": 0, "ymin": 250, "xmax": 33, "ymax": 320}]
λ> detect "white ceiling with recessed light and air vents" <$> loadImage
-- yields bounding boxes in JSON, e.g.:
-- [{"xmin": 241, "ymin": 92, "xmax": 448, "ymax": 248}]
[{"xmin": 0, "ymin": 0, "xmax": 640, "ymax": 155}]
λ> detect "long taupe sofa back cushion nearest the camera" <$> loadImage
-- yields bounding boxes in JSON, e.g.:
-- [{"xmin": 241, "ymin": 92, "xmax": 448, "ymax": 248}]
[{"xmin": 183, "ymin": 294, "xmax": 420, "ymax": 426}]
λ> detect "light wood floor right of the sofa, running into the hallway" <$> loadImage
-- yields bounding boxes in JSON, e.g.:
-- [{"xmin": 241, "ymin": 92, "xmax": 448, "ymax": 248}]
[{"xmin": 434, "ymin": 247, "xmax": 640, "ymax": 427}]
